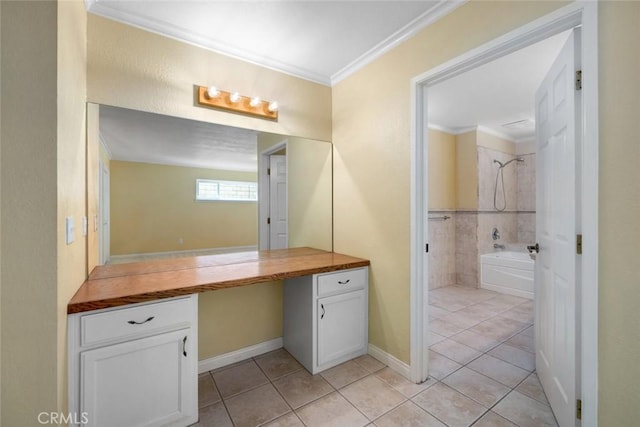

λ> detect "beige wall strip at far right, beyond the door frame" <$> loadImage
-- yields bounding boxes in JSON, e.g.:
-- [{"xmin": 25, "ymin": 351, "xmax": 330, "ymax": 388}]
[{"xmin": 596, "ymin": 2, "xmax": 640, "ymax": 426}]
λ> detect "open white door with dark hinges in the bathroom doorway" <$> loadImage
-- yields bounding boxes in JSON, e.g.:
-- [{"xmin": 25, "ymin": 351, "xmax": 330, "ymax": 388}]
[{"xmin": 535, "ymin": 29, "xmax": 581, "ymax": 427}]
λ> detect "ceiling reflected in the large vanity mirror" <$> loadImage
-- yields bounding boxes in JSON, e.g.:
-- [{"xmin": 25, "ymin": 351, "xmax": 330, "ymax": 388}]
[{"xmin": 100, "ymin": 105, "xmax": 258, "ymax": 172}]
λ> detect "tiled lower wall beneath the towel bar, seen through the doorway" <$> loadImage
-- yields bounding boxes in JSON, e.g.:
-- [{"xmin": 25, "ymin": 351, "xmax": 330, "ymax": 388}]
[{"xmin": 429, "ymin": 211, "xmax": 457, "ymax": 289}]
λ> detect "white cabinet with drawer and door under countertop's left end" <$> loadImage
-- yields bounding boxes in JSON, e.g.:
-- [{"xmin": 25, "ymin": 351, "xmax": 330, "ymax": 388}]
[{"xmin": 69, "ymin": 295, "xmax": 198, "ymax": 426}]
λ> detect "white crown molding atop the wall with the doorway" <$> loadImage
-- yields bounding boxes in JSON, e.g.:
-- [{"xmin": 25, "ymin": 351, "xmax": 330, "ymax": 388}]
[{"xmin": 331, "ymin": 0, "xmax": 468, "ymax": 86}]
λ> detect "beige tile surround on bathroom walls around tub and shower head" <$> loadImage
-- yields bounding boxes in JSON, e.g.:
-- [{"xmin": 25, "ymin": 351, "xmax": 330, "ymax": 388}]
[{"xmin": 429, "ymin": 146, "xmax": 536, "ymax": 289}]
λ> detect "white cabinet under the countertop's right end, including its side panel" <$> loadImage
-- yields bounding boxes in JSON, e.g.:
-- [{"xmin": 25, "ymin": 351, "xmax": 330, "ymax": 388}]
[{"xmin": 283, "ymin": 267, "xmax": 369, "ymax": 374}]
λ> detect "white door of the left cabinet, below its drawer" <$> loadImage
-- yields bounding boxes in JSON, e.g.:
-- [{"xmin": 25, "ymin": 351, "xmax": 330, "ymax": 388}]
[{"xmin": 80, "ymin": 329, "xmax": 198, "ymax": 426}]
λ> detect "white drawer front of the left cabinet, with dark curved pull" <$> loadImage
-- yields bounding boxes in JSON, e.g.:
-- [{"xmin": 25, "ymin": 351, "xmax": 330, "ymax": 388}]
[{"xmin": 80, "ymin": 298, "xmax": 192, "ymax": 347}]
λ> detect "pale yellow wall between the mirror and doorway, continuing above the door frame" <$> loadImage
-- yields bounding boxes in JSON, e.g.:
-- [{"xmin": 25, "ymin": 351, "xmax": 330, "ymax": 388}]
[{"xmin": 332, "ymin": 1, "xmax": 559, "ymax": 362}]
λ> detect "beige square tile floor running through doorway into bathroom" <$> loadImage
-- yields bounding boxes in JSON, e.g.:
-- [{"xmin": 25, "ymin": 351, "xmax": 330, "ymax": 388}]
[{"xmin": 196, "ymin": 286, "xmax": 557, "ymax": 427}]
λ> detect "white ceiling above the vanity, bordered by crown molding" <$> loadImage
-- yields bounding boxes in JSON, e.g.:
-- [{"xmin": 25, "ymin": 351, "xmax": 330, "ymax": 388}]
[{"xmin": 86, "ymin": 0, "xmax": 466, "ymax": 85}]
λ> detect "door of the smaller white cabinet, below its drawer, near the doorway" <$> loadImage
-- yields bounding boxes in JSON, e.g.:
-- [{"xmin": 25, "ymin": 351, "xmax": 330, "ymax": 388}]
[{"xmin": 317, "ymin": 290, "xmax": 367, "ymax": 366}]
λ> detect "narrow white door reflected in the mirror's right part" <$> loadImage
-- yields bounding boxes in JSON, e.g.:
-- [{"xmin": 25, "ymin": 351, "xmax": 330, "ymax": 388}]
[{"xmin": 269, "ymin": 155, "xmax": 289, "ymax": 249}]
